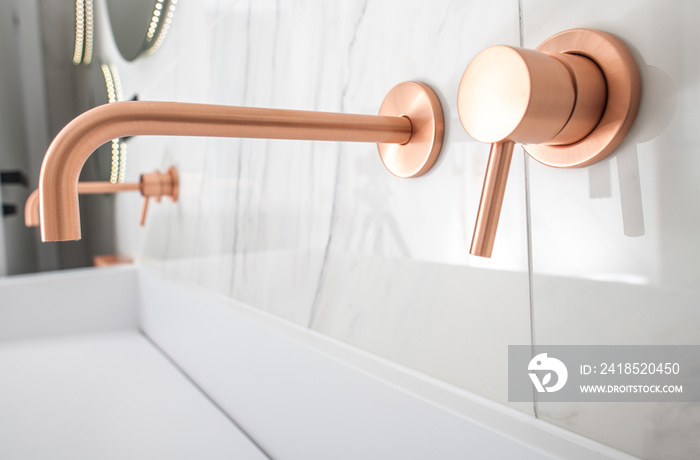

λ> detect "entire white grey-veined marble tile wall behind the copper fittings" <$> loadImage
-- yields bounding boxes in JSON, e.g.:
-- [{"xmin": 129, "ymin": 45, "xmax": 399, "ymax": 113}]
[{"xmin": 85, "ymin": 0, "xmax": 700, "ymax": 459}]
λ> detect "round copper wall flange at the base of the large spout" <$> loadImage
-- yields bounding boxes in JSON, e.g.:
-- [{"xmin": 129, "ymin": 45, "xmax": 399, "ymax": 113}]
[{"xmin": 377, "ymin": 81, "xmax": 445, "ymax": 178}]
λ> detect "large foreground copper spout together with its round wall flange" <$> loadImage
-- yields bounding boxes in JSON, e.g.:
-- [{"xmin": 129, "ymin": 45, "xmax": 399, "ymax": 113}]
[{"xmin": 39, "ymin": 82, "xmax": 444, "ymax": 241}]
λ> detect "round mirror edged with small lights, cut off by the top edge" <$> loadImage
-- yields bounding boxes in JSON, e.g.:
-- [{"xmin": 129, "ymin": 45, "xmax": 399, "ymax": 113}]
[{"xmin": 107, "ymin": 0, "xmax": 177, "ymax": 61}]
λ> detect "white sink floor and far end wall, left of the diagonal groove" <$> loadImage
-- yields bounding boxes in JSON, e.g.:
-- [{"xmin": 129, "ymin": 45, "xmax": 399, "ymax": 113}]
[{"xmin": 0, "ymin": 270, "xmax": 267, "ymax": 460}]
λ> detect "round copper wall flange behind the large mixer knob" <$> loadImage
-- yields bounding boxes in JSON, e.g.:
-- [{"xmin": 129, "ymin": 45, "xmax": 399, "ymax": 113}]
[{"xmin": 523, "ymin": 29, "xmax": 642, "ymax": 168}]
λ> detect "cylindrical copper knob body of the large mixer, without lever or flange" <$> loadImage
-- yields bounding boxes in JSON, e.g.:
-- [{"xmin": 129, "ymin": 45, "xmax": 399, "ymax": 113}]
[{"xmin": 458, "ymin": 45, "xmax": 606, "ymax": 144}]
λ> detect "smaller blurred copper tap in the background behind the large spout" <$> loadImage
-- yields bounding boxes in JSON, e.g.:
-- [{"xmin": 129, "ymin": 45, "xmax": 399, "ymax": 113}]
[{"xmin": 29, "ymin": 166, "xmax": 179, "ymax": 227}]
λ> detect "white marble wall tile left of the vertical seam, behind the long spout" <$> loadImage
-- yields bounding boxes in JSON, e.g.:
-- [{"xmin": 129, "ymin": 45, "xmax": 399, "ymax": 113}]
[{"xmin": 108, "ymin": 0, "xmax": 533, "ymax": 413}]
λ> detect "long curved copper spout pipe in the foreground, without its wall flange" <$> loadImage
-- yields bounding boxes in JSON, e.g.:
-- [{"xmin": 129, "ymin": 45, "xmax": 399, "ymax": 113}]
[{"xmin": 39, "ymin": 101, "xmax": 412, "ymax": 241}]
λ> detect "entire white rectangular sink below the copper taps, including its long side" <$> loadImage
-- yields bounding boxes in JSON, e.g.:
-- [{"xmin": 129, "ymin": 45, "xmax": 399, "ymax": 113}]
[{"xmin": 0, "ymin": 267, "xmax": 631, "ymax": 459}]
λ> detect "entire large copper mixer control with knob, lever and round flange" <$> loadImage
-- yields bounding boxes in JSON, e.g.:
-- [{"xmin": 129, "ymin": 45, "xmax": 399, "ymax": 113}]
[{"xmin": 458, "ymin": 29, "xmax": 641, "ymax": 257}]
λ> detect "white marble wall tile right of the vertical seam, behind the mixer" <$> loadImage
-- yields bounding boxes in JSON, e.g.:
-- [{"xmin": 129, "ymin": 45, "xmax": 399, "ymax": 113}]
[{"xmin": 523, "ymin": 0, "xmax": 700, "ymax": 459}]
